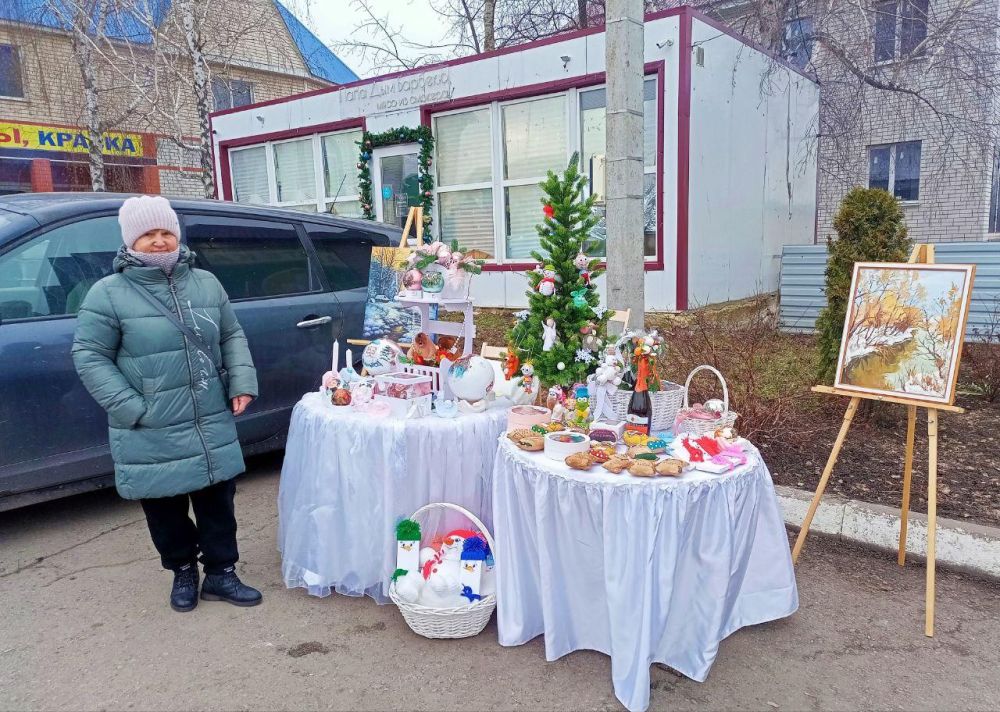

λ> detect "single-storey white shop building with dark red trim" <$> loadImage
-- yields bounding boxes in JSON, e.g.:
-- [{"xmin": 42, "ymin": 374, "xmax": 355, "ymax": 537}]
[{"xmin": 212, "ymin": 7, "xmax": 819, "ymax": 310}]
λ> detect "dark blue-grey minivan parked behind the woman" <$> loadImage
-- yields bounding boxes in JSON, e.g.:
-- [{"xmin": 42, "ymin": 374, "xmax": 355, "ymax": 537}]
[{"xmin": 0, "ymin": 193, "xmax": 400, "ymax": 511}]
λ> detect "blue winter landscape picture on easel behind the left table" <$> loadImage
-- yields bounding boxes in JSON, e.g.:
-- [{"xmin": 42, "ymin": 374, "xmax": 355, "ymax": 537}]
[{"xmin": 364, "ymin": 247, "xmax": 420, "ymax": 343}]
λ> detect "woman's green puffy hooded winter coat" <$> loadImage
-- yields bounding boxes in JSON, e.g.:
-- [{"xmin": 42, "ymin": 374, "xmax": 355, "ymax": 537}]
[{"xmin": 73, "ymin": 247, "xmax": 257, "ymax": 499}]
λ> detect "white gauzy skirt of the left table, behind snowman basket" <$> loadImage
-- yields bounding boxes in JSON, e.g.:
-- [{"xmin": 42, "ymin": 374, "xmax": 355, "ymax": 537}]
[{"xmin": 278, "ymin": 393, "xmax": 507, "ymax": 603}]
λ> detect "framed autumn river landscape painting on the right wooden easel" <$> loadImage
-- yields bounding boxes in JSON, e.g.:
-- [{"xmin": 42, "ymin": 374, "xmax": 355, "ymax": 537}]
[{"xmin": 834, "ymin": 262, "xmax": 976, "ymax": 405}]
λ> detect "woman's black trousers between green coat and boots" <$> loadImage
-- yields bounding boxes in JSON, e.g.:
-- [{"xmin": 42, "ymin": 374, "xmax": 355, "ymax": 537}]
[{"xmin": 139, "ymin": 480, "xmax": 240, "ymax": 574}]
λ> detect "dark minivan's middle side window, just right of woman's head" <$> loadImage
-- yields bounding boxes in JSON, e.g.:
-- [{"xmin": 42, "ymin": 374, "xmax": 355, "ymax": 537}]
[{"xmin": 185, "ymin": 216, "xmax": 320, "ymax": 301}]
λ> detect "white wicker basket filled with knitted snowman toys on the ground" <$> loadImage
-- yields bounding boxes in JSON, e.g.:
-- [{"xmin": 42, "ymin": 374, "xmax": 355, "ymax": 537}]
[{"xmin": 389, "ymin": 502, "xmax": 497, "ymax": 638}]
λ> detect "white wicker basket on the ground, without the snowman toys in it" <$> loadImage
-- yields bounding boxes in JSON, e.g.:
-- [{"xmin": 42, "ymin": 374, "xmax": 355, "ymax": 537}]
[{"xmin": 389, "ymin": 502, "xmax": 497, "ymax": 638}]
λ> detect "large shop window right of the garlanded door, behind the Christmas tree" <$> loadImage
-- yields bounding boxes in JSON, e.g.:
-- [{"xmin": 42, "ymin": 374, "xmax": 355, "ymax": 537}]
[{"xmin": 433, "ymin": 78, "xmax": 659, "ymax": 262}]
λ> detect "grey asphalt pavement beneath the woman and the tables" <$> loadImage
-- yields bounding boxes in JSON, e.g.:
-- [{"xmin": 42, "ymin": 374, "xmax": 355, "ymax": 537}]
[{"xmin": 0, "ymin": 457, "xmax": 1000, "ymax": 712}]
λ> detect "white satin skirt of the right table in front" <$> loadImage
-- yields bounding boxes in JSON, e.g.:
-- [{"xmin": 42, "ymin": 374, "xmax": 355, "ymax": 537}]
[{"xmin": 493, "ymin": 439, "xmax": 798, "ymax": 710}]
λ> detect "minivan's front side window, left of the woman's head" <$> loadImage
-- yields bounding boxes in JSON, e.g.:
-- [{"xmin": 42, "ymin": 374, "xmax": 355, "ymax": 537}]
[{"xmin": 0, "ymin": 215, "xmax": 122, "ymax": 321}]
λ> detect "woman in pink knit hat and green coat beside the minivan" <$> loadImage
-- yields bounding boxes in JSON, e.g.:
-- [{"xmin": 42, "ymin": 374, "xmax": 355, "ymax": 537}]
[{"xmin": 73, "ymin": 196, "xmax": 262, "ymax": 611}]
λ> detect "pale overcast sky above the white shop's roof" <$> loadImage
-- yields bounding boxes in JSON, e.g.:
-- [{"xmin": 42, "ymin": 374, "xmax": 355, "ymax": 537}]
[{"xmin": 285, "ymin": 0, "xmax": 454, "ymax": 77}]
